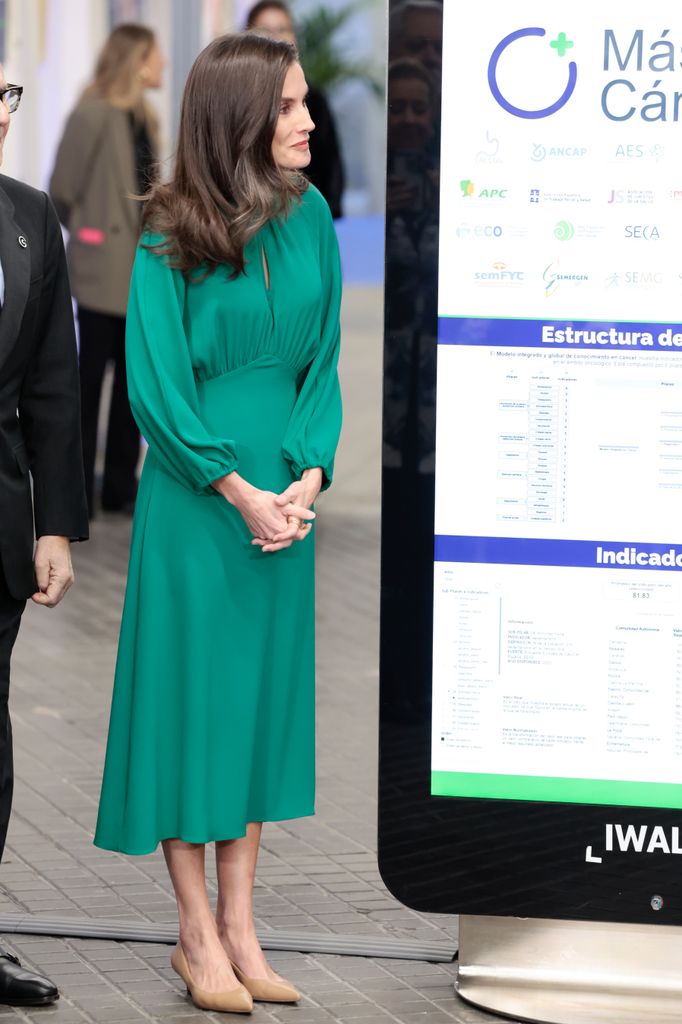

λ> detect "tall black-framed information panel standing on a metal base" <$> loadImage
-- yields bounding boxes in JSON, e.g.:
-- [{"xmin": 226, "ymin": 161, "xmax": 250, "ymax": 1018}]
[{"xmin": 379, "ymin": 0, "xmax": 682, "ymax": 1021}]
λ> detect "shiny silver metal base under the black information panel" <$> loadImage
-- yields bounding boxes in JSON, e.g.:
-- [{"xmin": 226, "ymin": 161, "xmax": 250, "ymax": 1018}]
[{"xmin": 455, "ymin": 915, "xmax": 682, "ymax": 1024}]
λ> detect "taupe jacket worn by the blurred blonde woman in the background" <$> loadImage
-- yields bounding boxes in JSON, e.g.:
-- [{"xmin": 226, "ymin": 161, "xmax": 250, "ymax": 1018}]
[{"xmin": 49, "ymin": 96, "xmax": 150, "ymax": 316}]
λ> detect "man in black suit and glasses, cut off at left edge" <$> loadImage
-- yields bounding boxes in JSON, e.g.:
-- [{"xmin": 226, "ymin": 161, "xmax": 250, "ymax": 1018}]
[{"xmin": 0, "ymin": 74, "xmax": 88, "ymax": 1006}]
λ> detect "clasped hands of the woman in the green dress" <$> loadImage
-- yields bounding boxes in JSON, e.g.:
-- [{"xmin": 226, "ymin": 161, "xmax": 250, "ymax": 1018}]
[{"xmin": 213, "ymin": 469, "xmax": 322, "ymax": 553}]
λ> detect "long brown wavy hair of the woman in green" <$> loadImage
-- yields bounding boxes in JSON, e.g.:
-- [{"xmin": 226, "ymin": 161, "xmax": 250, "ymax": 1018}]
[{"xmin": 143, "ymin": 33, "xmax": 307, "ymax": 278}]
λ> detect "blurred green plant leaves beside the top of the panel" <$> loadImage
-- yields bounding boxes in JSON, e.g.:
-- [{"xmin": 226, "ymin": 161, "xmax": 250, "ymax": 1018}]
[{"xmin": 296, "ymin": 0, "xmax": 384, "ymax": 97}]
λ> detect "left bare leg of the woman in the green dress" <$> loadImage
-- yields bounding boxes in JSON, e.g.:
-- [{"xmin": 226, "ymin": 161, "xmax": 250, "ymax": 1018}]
[{"xmin": 162, "ymin": 839, "xmax": 239, "ymax": 992}]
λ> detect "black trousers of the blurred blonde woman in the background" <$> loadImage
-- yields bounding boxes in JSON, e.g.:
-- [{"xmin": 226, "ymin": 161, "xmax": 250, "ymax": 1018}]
[{"xmin": 78, "ymin": 306, "xmax": 139, "ymax": 518}]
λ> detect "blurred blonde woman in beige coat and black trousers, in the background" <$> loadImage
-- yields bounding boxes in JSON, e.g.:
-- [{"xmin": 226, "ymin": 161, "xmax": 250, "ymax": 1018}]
[{"xmin": 50, "ymin": 25, "xmax": 164, "ymax": 518}]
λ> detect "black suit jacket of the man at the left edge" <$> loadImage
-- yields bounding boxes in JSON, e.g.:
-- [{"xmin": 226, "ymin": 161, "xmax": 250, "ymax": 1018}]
[{"xmin": 0, "ymin": 175, "xmax": 88, "ymax": 599}]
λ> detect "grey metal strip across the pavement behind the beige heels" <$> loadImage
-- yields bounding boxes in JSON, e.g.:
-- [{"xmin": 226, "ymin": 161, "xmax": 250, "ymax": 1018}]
[{"xmin": 0, "ymin": 913, "xmax": 456, "ymax": 964}]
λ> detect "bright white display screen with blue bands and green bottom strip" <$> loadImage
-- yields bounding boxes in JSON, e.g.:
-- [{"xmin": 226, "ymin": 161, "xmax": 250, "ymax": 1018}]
[{"xmin": 431, "ymin": 6, "xmax": 682, "ymax": 808}]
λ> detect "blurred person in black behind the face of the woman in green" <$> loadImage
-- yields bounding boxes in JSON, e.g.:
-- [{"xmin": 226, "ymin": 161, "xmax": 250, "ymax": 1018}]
[{"xmin": 246, "ymin": 0, "xmax": 345, "ymax": 219}]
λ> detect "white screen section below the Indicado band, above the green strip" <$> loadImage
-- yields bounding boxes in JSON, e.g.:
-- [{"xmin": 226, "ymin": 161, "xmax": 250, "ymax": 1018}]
[{"xmin": 433, "ymin": 563, "xmax": 682, "ymax": 784}]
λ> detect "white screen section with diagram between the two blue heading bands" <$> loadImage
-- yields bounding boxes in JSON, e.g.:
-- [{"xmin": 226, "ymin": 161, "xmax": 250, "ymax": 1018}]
[{"xmin": 436, "ymin": 344, "xmax": 682, "ymax": 544}]
